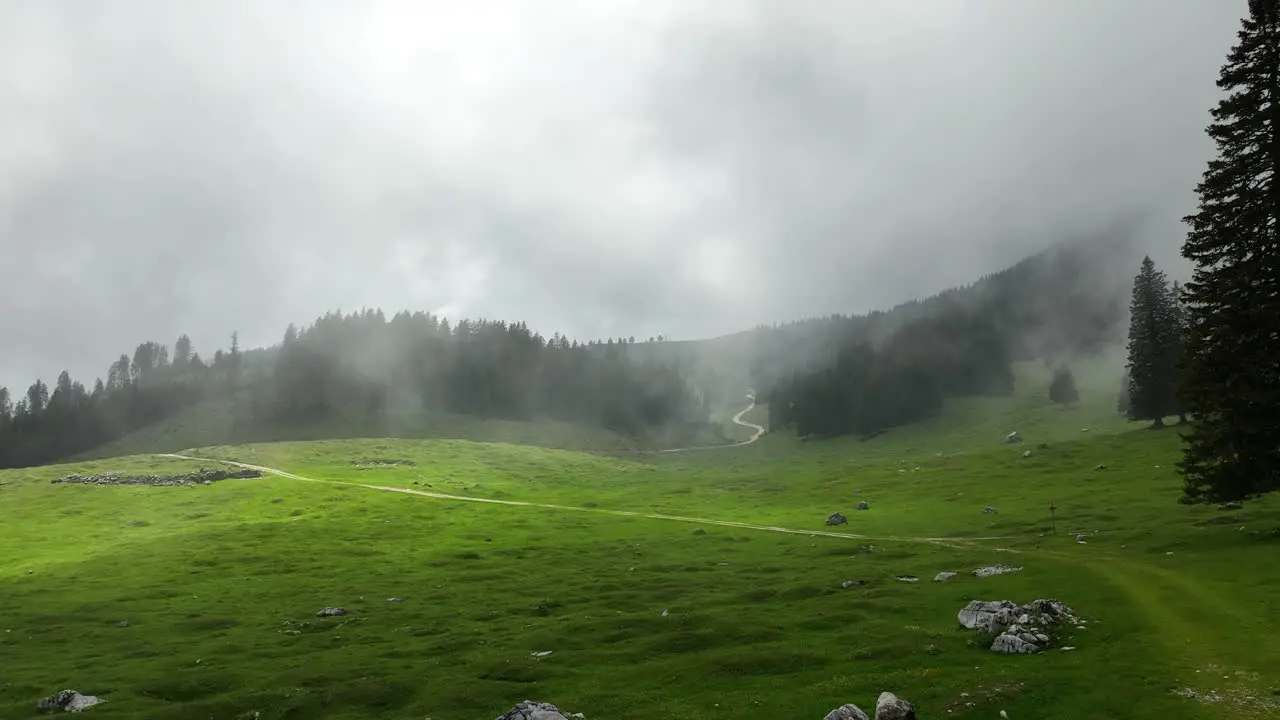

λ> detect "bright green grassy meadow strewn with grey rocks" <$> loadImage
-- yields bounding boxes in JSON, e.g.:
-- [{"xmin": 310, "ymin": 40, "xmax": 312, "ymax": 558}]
[{"xmin": 0, "ymin": 356, "xmax": 1280, "ymax": 720}]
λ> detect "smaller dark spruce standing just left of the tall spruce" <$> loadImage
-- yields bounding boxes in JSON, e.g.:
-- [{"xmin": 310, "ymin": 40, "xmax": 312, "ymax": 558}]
[{"xmin": 1128, "ymin": 258, "xmax": 1178, "ymax": 428}]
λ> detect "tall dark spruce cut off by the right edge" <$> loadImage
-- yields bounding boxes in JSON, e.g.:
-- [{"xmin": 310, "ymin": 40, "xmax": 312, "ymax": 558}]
[{"xmin": 1179, "ymin": 0, "xmax": 1280, "ymax": 502}]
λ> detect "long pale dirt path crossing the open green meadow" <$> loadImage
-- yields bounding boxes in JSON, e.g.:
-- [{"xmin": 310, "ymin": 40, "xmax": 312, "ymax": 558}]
[{"xmin": 157, "ymin": 450, "xmax": 1011, "ymax": 544}]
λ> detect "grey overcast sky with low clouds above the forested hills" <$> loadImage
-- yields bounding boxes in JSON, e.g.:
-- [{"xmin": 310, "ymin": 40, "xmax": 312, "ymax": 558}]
[{"xmin": 0, "ymin": 0, "xmax": 1245, "ymax": 391}]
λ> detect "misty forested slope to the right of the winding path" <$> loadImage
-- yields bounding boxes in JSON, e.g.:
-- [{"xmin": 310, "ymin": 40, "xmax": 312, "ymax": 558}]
[{"xmin": 753, "ymin": 238, "xmax": 1124, "ymax": 436}]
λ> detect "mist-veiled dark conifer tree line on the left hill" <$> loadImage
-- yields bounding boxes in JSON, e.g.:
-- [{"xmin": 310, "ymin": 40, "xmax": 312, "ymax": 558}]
[{"xmin": 0, "ymin": 310, "xmax": 708, "ymax": 468}]
